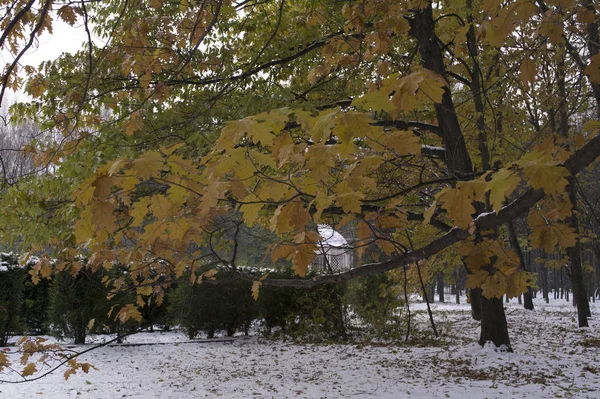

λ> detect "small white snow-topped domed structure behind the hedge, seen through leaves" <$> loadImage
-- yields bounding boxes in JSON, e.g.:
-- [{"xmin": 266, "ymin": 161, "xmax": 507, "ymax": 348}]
[{"xmin": 310, "ymin": 224, "xmax": 353, "ymax": 274}]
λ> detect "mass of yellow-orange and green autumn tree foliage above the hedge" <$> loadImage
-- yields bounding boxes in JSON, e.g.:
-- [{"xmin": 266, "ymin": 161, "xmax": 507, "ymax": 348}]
[{"xmin": 0, "ymin": 0, "xmax": 600, "ymax": 356}]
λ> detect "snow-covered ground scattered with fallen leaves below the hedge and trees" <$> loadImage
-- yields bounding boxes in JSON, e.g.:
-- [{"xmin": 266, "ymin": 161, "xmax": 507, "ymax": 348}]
[{"xmin": 0, "ymin": 300, "xmax": 600, "ymax": 399}]
